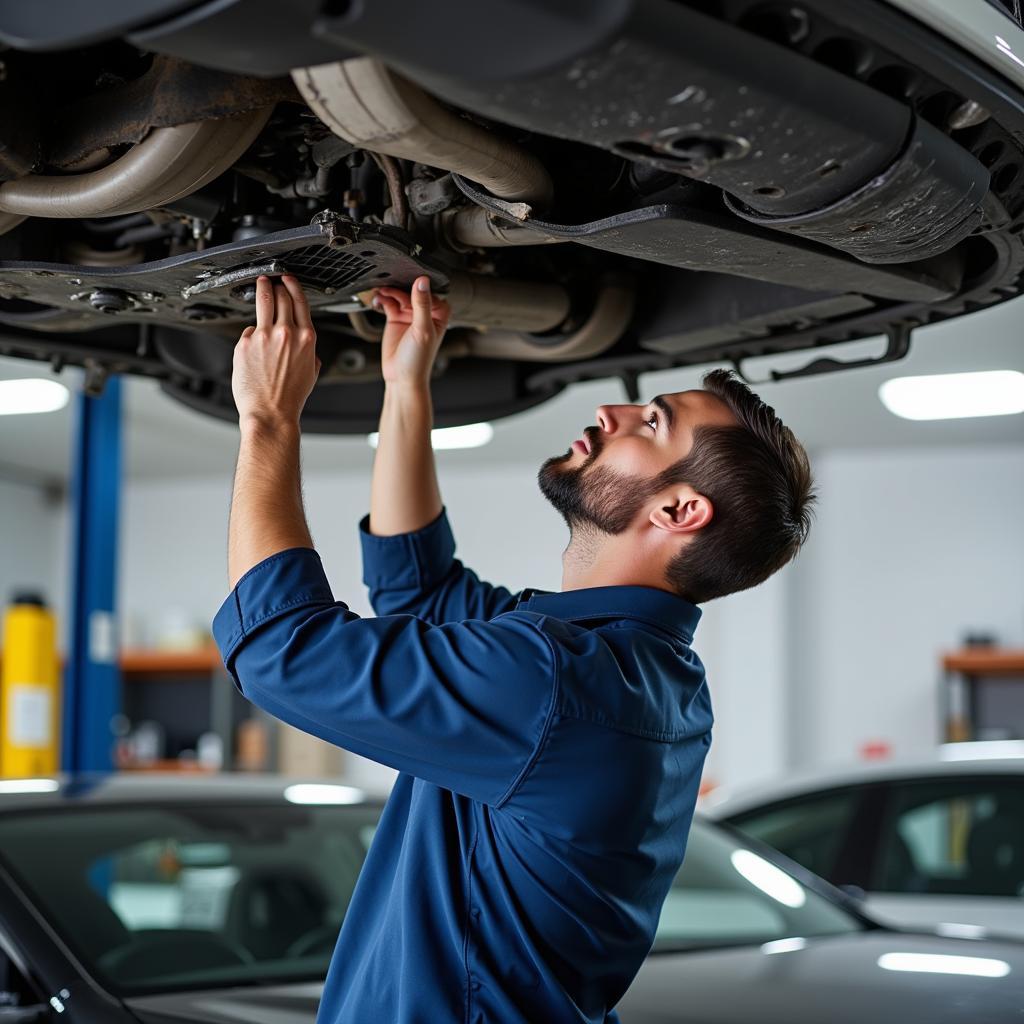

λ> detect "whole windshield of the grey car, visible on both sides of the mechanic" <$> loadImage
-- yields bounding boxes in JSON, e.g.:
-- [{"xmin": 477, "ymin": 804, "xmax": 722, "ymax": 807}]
[{"xmin": 0, "ymin": 803, "xmax": 859, "ymax": 995}]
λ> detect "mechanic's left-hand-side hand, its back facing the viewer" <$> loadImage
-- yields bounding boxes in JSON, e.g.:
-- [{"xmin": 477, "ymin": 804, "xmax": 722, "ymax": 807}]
[{"xmin": 231, "ymin": 274, "xmax": 321, "ymax": 426}]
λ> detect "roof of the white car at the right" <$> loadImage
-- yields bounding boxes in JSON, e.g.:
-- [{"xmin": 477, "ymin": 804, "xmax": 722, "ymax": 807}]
[{"xmin": 700, "ymin": 743, "xmax": 1024, "ymax": 820}]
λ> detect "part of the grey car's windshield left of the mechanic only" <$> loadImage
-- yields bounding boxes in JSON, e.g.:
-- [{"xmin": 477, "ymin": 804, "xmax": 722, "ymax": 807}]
[{"xmin": 0, "ymin": 802, "xmax": 380, "ymax": 995}]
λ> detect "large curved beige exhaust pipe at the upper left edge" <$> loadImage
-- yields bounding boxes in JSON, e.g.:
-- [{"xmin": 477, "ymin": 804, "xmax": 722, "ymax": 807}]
[{"xmin": 0, "ymin": 106, "xmax": 270, "ymax": 218}]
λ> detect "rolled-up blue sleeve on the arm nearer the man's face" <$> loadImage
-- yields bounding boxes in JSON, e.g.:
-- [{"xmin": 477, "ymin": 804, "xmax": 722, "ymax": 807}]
[{"xmin": 359, "ymin": 508, "xmax": 516, "ymax": 625}]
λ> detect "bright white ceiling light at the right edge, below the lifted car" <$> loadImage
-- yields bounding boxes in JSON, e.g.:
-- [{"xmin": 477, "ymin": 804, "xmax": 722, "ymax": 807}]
[{"xmin": 879, "ymin": 370, "xmax": 1024, "ymax": 420}]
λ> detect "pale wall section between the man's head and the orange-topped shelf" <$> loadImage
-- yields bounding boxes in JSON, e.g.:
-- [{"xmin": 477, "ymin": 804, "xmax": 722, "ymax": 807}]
[{"xmin": 791, "ymin": 445, "xmax": 1024, "ymax": 765}]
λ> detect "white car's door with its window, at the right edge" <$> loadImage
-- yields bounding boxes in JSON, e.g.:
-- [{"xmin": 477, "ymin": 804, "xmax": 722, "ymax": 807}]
[{"xmin": 867, "ymin": 775, "xmax": 1024, "ymax": 938}]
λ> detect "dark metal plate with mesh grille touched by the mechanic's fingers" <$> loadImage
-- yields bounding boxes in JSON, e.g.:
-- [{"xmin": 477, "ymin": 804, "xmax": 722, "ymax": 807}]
[{"xmin": 0, "ymin": 213, "xmax": 449, "ymax": 326}]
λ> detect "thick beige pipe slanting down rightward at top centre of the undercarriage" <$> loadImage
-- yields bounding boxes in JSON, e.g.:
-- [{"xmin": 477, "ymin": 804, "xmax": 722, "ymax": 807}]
[{"xmin": 292, "ymin": 57, "xmax": 553, "ymax": 205}]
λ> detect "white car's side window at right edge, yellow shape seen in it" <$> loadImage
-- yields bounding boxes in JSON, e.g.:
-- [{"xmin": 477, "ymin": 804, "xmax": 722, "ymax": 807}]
[{"xmin": 871, "ymin": 778, "xmax": 1024, "ymax": 896}]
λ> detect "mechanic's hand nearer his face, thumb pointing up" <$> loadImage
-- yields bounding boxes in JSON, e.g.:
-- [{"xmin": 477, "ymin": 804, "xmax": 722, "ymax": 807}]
[{"xmin": 373, "ymin": 276, "xmax": 451, "ymax": 387}]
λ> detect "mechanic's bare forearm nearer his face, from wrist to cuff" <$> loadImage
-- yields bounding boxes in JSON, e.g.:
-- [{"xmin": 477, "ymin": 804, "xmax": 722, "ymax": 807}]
[{"xmin": 370, "ymin": 384, "xmax": 441, "ymax": 537}]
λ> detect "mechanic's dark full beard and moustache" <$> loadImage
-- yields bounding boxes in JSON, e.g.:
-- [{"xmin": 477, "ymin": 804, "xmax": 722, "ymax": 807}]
[{"xmin": 537, "ymin": 438, "xmax": 654, "ymax": 537}]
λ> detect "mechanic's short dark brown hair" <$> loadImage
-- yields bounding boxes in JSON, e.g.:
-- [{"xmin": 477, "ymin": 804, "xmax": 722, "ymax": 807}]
[{"xmin": 657, "ymin": 370, "xmax": 817, "ymax": 604}]
